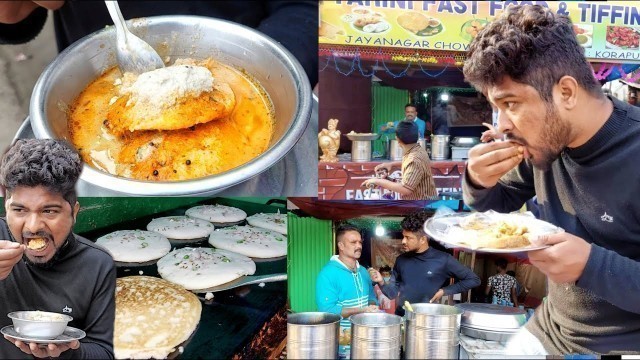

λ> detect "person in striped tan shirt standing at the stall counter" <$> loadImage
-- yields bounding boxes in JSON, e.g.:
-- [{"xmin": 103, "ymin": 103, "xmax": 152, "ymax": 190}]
[{"xmin": 362, "ymin": 121, "xmax": 438, "ymax": 200}]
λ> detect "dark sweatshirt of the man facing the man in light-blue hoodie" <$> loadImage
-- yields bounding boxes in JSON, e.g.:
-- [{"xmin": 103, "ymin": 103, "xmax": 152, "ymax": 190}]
[{"xmin": 381, "ymin": 248, "xmax": 480, "ymax": 316}]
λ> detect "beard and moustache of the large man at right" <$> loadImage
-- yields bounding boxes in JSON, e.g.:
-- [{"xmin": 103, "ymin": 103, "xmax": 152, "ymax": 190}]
[{"xmin": 507, "ymin": 105, "xmax": 571, "ymax": 171}]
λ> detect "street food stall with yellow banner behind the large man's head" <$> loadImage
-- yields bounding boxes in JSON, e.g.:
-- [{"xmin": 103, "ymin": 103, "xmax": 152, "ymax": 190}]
[{"xmin": 318, "ymin": 1, "xmax": 640, "ymax": 200}]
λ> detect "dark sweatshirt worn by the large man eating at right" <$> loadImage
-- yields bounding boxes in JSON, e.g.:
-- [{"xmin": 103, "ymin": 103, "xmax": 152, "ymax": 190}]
[{"xmin": 463, "ymin": 99, "xmax": 640, "ymax": 354}]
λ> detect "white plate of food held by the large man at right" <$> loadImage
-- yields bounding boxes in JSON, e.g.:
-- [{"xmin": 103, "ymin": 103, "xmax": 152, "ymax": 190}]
[{"xmin": 424, "ymin": 211, "xmax": 564, "ymax": 253}]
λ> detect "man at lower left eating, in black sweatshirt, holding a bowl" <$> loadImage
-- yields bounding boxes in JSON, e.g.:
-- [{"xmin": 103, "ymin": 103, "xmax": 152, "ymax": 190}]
[{"xmin": 0, "ymin": 139, "xmax": 116, "ymax": 359}]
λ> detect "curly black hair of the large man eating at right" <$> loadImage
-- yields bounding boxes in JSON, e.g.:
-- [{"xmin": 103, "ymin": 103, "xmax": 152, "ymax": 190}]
[{"xmin": 463, "ymin": 5, "xmax": 604, "ymax": 104}]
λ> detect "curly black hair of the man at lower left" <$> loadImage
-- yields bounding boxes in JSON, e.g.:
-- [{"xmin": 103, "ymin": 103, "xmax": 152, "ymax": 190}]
[{"xmin": 0, "ymin": 139, "xmax": 82, "ymax": 208}]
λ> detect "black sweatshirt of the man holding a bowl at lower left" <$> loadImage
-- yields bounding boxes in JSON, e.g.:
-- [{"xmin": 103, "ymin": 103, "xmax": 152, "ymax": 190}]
[{"xmin": 0, "ymin": 218, "xmax": 116, "ymax": 359}]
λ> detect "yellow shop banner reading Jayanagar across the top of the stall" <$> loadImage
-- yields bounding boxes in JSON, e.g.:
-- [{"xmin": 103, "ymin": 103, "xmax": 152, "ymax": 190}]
[{"xmin": 319, "ymin": 1, "xmax": 640, "ymax": 62}]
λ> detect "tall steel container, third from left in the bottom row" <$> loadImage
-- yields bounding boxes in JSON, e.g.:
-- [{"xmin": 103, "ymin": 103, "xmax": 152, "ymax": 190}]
[{"xmin": 405, "ymin": 304, "xmax": 463, "ymax": 359}]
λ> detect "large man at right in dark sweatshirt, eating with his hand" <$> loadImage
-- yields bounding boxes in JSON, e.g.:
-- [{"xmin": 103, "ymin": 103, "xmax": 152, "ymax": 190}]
[{"xmin": 462, "ymin": 5, "xmax": 640, "ymax": 356}]
